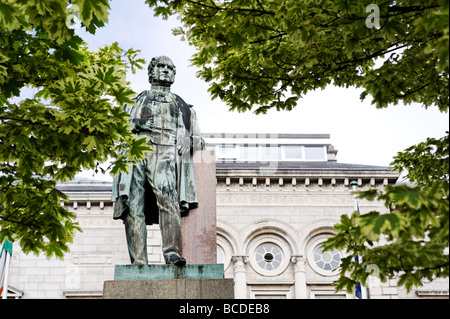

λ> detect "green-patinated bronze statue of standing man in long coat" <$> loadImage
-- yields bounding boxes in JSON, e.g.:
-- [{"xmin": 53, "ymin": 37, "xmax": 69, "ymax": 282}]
[{"xmin": 112, "ymin": 56, "xmax": 205, "ymax": 266}]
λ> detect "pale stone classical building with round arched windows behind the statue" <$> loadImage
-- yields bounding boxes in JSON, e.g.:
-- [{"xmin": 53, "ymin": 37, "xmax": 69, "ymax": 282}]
[{"xmin": 4, "ymin": 134, "xmax": 448, "ymax": 299}]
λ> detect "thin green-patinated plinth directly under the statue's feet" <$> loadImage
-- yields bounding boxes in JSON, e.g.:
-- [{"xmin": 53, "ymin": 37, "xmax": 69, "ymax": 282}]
[{"xmin": 114, "ymin": 264, "xmax": 224, "ymax": 280}]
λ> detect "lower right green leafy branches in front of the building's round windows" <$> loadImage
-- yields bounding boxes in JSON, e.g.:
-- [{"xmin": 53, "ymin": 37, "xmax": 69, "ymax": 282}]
[{"xmin": 324, "ymin": 134, "xmax": 449, "ymax": 291}]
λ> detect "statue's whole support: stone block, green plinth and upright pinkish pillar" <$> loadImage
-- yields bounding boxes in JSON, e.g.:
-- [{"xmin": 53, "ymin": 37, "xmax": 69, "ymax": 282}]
[{"xmin": 103, "ymin": 151, "xmax": 229, "ymax": 299}]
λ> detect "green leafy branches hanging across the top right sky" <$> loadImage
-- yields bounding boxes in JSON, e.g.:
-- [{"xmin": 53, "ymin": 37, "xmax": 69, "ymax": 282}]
[{"xmin": 146, "ymin": 0, "xmax": 449, "ymax": 113}]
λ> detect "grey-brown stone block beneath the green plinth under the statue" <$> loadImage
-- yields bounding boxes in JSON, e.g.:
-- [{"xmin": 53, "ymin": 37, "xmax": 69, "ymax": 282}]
[{"xmin": 103, "ymin": 279, "xmax": 234, "ymax": 299}]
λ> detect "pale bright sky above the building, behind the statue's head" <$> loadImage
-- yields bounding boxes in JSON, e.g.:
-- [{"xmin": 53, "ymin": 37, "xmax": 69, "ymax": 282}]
[{"xmin": 77, "ymin": 0, "xmax": 449, "ymax": 177}]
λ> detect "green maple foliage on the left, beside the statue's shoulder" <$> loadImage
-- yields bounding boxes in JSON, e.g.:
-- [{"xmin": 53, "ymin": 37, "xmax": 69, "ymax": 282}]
[{"xmin": 0, "ymin": 0, "xmax": 149, "ymax": 257}]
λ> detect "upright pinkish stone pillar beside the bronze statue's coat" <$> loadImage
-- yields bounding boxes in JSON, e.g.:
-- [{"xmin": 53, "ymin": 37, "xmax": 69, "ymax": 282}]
[{"xmin": 180, "ymin": 150, "xmax": 217, "ymax": 264}]
